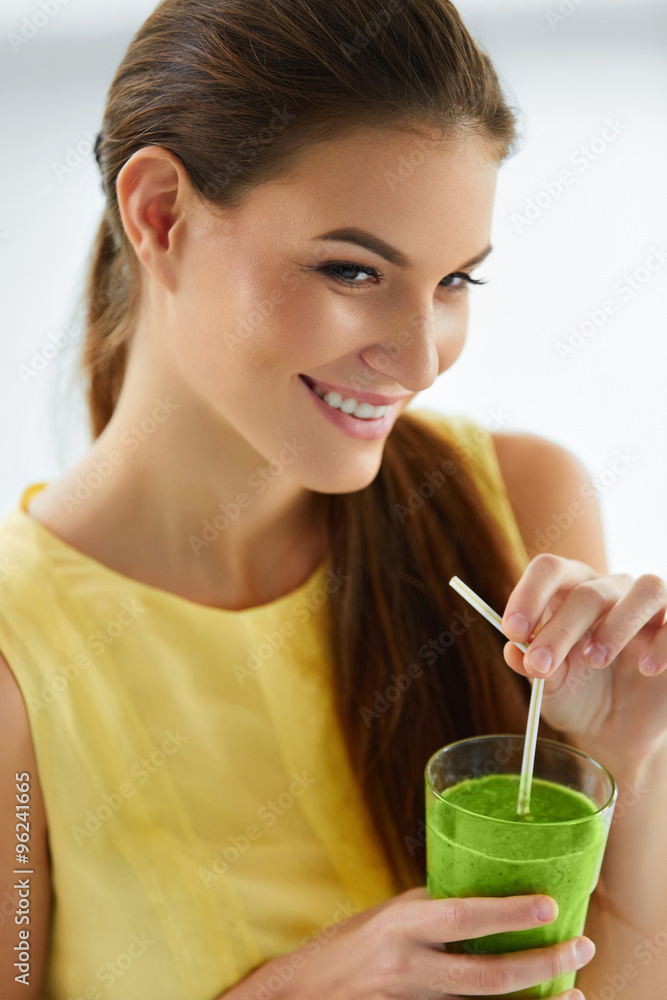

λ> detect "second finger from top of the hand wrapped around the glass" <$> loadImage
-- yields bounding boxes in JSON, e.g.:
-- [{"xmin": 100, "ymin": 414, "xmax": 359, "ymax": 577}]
[{"xmin": 423, "ymin": 937, "xmax": 595, "ymax": 997}]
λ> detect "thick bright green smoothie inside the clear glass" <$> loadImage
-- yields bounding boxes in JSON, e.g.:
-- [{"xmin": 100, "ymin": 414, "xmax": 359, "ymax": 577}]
[{"xmin": 426, "ymin": 774, "xmax": 607, "ymax": 997}]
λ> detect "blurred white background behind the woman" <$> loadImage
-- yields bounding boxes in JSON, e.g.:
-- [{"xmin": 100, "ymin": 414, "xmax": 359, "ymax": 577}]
[{"xmin": 0, "ymin": 0, "xmax": 667, "ymax": 576}]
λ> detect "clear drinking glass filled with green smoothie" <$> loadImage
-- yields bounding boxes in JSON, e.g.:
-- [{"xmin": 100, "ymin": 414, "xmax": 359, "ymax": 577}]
[{"xmin": 425, "ymin": 735, "xmax": 617, "ymax": 1000}]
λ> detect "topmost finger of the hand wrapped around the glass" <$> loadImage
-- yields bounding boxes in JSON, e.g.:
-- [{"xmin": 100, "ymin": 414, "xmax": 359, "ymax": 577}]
[{"xmin": 396, "ymin": 895, "xmax": 558, "ymax": 944}]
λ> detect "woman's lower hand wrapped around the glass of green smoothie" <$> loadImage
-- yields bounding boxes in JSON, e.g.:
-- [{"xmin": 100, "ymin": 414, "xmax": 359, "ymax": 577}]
[{"xmin": 244, "ymin": 886, "xmax": 595, "ymax": 1000}]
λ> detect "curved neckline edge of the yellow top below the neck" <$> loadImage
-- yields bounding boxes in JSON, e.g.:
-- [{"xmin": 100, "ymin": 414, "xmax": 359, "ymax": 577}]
[{"xmin": 15, "ymin": 482, "xmax": 328, "ymax": 617}]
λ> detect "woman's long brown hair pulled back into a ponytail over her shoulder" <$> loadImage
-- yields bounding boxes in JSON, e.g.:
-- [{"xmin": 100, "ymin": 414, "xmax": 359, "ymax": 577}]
[{"xmin": 83, "ymin": 0, "xmax": 554, "ymax": 890}]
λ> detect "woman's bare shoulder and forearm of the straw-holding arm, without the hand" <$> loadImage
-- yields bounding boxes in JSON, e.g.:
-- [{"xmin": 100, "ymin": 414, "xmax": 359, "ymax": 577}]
[{"xmin": 493, "ymin": 433, "xmax": 667, "ymax": 1000}]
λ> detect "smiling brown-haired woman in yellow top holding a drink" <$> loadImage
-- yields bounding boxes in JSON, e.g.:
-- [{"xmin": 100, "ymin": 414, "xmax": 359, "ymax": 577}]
[{"xmin": 0, "ymin": 0, "xmax": 667, "ymax": 1000}]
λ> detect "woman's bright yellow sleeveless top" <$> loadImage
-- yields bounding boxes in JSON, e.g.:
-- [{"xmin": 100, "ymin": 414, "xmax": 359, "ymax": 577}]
[{"xmin": 0, "ymin": 410, "xmax": 527, "ymax": 1000}]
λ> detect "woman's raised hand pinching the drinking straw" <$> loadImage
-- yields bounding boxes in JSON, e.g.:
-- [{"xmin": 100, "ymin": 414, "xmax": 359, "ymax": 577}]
[{"xmin": 503, "ymin": 552, "xmax": 667, "ymax": 762}]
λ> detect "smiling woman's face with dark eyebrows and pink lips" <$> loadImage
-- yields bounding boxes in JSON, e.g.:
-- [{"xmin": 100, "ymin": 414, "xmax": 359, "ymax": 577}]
[{"xmin": 146, "ymin": 130, "xmax": 498, "ymax": 493}]
